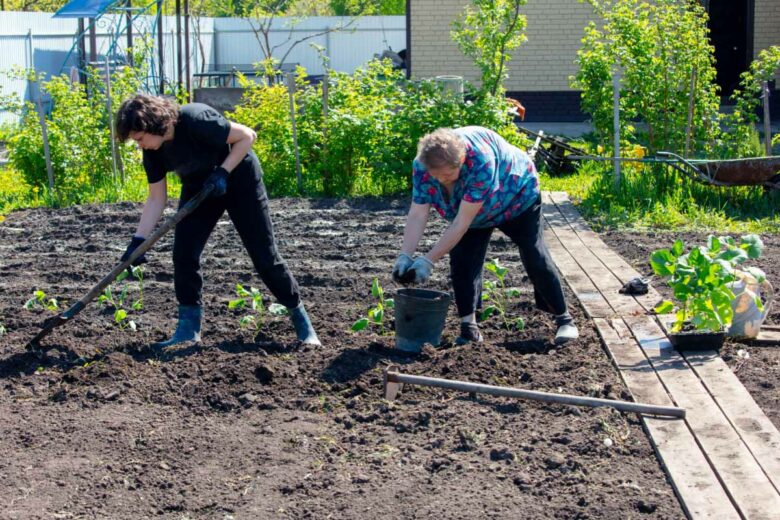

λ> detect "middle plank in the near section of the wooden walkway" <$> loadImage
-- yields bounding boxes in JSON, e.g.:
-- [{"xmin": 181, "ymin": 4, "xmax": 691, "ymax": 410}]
[{"xmin": 624, "ymin": 316, "xmax": 780, "ymax": 519}]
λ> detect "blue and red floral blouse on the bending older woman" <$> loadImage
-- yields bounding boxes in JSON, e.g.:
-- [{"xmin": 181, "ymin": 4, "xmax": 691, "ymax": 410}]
[{"xmin": 412, "ymin": 126, "xmax": 539, "ymax": 228}]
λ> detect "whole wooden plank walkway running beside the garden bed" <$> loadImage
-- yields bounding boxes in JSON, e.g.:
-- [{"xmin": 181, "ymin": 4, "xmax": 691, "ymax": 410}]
[{"xmin": 543, "ymin": 192, "xmax": 780, "ymax": 519}]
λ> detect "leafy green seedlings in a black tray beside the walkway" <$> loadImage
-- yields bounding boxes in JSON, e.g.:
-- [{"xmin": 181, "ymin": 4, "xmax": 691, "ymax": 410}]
[{"xmin": 650, "ymin": 235, "xmax": 766, "ymax": 350}]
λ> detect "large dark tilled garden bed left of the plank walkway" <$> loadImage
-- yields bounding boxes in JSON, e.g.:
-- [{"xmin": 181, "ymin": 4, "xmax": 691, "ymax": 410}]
[{"xmin": 0, "ymin": 199, "xmax": 684, "ymax": 519}]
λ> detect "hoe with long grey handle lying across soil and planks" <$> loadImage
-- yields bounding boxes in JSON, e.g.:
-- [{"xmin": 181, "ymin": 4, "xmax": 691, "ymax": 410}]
[{"xmin": 384, "ymin": 365, "xmax": 685, "ymax": 419}]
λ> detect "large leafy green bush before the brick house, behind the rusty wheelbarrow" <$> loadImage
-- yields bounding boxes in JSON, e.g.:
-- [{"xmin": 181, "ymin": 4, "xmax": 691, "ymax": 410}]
[{"xmin": 571, "ymin": 0, "xmax": 720, "ymax": 154}]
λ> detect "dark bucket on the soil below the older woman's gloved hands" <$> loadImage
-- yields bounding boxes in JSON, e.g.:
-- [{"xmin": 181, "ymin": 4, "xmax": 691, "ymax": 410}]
[{"xmin": 395, "ymin": 289, "xmax": 452, "ymax": 352}]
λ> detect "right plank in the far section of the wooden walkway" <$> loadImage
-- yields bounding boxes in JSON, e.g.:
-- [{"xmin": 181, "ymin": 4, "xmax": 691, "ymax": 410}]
[{"xmin": 550, "ymin": 191, "xmax": 662, "ymax": 311}]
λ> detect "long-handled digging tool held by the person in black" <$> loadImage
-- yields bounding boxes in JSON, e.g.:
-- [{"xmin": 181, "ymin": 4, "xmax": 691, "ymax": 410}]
[{"xmin": 27, "ymin": 186, "xmax": 214, "ymax": 350}]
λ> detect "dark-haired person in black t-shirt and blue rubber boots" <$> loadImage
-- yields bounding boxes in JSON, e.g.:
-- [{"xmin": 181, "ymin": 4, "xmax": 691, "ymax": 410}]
[{"xmin": 116, "ymin": 95, "xmax": 320, "ymax": 348}]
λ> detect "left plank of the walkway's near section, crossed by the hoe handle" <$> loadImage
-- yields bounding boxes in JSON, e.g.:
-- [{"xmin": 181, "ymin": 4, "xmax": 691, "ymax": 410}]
[{"xmin": 594, "ymin": 318, "xmax": 739, "ymax": 519}]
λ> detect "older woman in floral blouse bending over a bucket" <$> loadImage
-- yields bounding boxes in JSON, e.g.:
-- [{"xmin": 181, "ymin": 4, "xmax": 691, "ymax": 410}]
[{"xmin": 393, "ymin": 126, "xmax": 579, "ymax": 344}]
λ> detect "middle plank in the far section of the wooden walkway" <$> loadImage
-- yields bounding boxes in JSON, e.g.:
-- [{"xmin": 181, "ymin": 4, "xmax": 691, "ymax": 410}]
[{"xmin": 542, "ymin": 194, "xmax": 645, "ymax": 316}]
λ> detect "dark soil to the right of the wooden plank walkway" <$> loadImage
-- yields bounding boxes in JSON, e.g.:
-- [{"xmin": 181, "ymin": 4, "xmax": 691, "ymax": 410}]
[{"xmin": 602, "ymin": 232, "xmax": 780, "ymax": 428}]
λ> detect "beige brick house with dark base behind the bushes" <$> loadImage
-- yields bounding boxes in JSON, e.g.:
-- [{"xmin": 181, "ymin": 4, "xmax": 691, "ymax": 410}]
[{"xmin": 406, "ymin": 0, "xmax": 780, "ymax": 121}]
